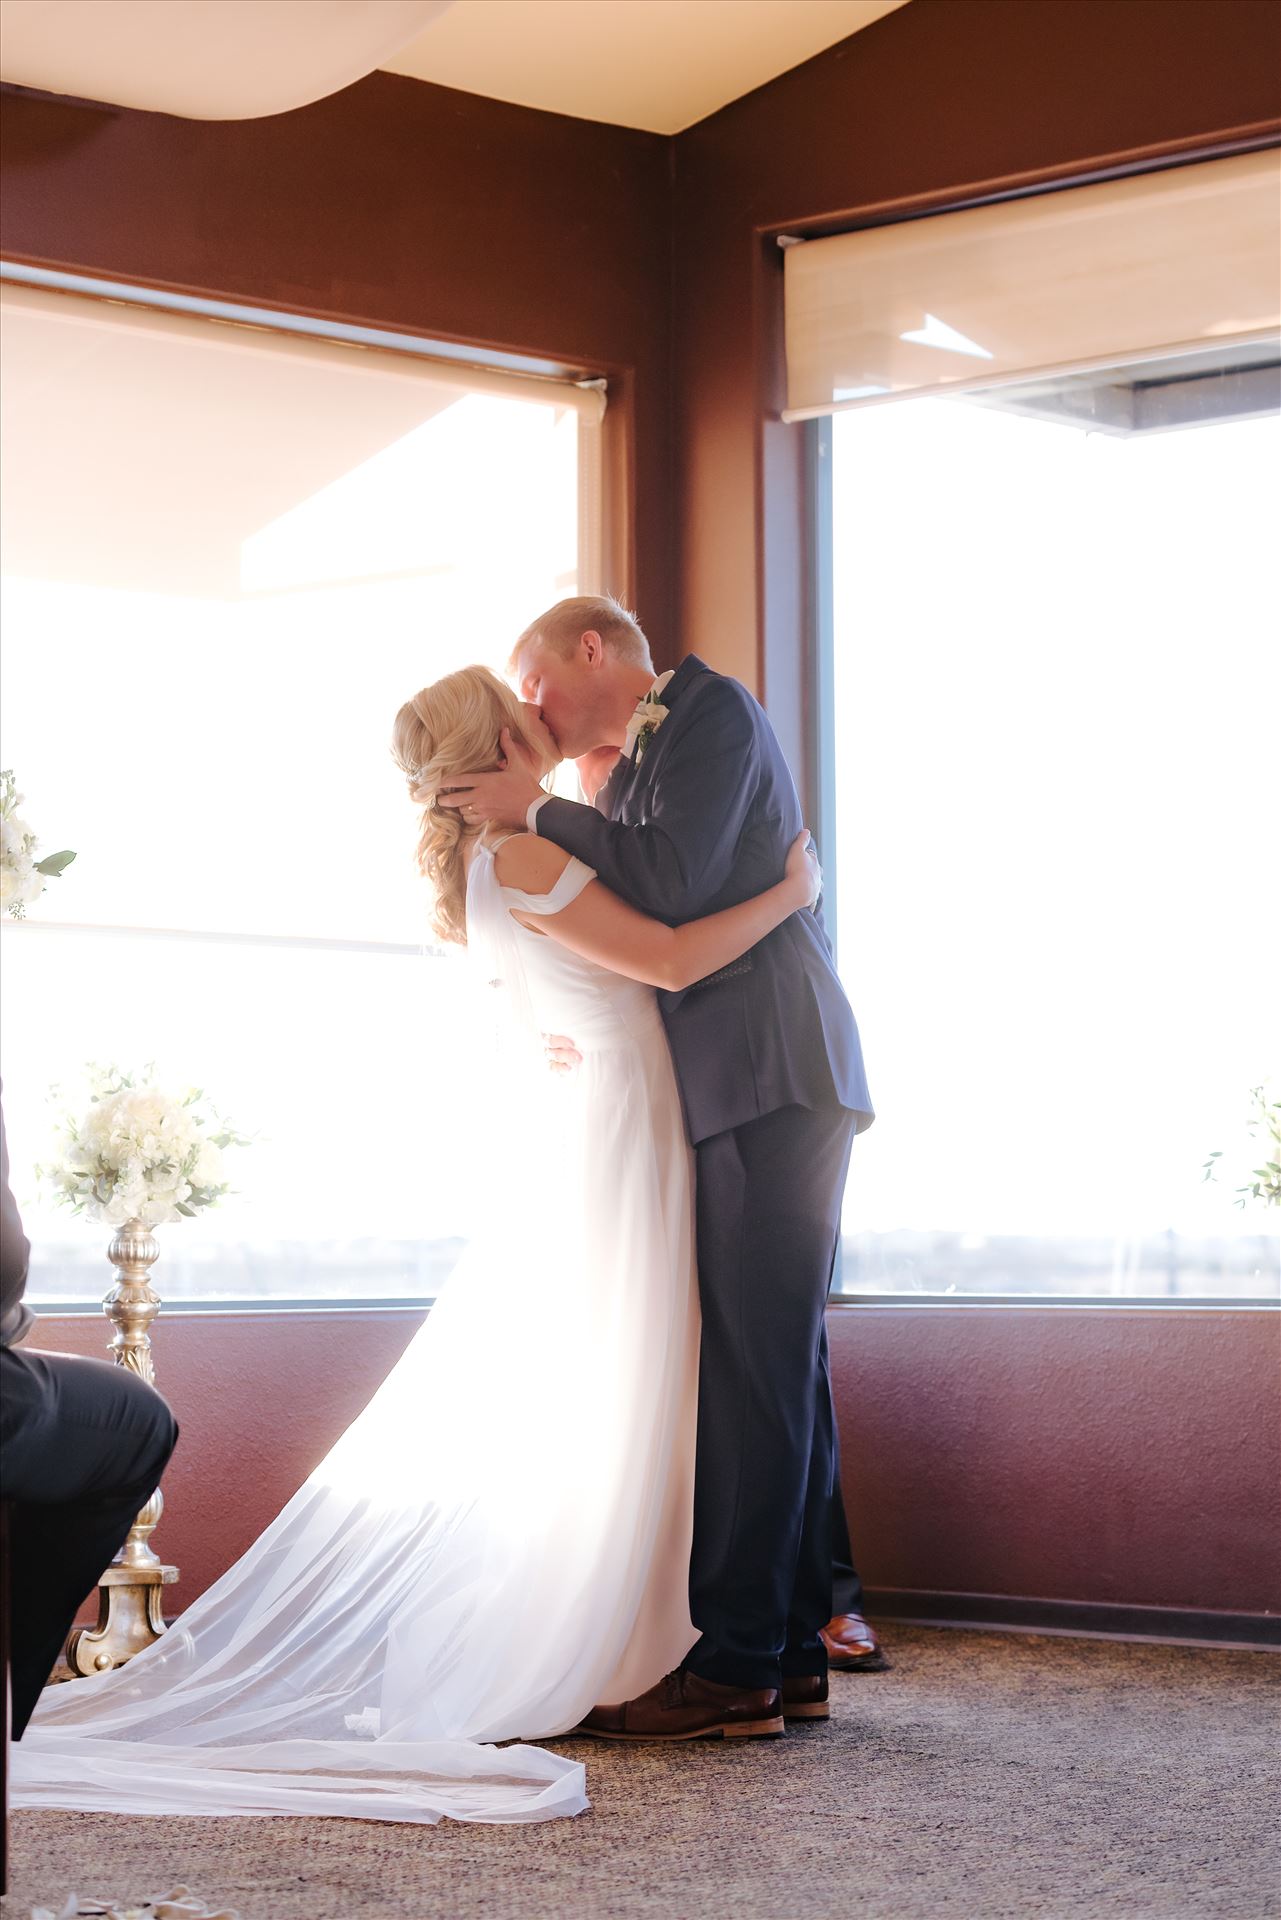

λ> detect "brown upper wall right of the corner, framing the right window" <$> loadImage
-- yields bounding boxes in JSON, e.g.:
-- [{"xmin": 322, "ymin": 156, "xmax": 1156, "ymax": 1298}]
[{"xmin": 674, "ymin": 0, "xmax": 1281, "ymax": 804}]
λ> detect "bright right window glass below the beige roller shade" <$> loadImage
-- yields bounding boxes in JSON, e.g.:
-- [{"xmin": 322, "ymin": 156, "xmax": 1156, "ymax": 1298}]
[{"xmin": 832, "ymin": 363, "xmax": 1281, "ymax": 1298}]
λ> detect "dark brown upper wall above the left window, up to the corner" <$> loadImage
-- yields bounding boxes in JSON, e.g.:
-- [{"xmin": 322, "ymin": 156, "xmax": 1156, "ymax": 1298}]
[{"xmin": 0, "ymin": 73, "xmax": 672, "ymax": 653}]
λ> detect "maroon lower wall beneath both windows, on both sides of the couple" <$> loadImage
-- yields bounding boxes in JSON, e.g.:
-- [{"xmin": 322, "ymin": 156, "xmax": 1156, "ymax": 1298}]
[{"xmin": 38, "ymin": 1304, "xmax": 1281, "ymax": 1613}]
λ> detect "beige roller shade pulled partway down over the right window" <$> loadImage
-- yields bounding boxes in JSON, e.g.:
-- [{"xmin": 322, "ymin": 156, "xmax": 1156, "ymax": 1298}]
[{"xmin": 784, "ymin": 150, "xmax": 1281, "ymax": 420}]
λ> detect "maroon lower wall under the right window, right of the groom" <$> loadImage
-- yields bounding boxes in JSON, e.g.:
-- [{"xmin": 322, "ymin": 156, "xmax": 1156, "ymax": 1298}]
[{"xmin": 828, "ymin": 1302, "xmax": 1281, "ymax": 1613}]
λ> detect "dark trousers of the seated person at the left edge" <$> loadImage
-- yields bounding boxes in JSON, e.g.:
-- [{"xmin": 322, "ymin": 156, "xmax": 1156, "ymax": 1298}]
[{"xmin": 0, "ymin": 1348, "xmax": 179, "ymax": 1740}]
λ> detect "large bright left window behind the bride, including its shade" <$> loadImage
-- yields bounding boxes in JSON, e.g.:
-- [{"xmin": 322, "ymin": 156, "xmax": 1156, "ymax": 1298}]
[{"xmin": 0, "ymin": 288, "xmax": 601, "ymax": 1302}]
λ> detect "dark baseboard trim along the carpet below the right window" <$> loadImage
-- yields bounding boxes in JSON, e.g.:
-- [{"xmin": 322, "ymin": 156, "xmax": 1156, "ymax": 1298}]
[{"xmin": 866, "ymin": 1586, "xmax": 1281, "ymax": 1651}]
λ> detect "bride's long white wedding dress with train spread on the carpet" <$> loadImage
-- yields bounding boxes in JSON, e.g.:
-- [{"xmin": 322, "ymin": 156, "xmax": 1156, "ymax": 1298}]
[{"xmin": 12, "ymin": 849, "xmax": 699, "ymax": 1822}]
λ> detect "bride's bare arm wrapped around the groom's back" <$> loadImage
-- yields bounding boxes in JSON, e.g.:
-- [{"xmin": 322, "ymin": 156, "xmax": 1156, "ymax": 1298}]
[{"xmin": 495, "ymin": 833, "xmax": 822, "ymax": 991}]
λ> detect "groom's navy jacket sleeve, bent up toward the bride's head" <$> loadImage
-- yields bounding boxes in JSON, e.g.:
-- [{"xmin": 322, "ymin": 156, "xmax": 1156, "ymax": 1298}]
[{"xmin": 536, "ymin": 680, "xmax": 778, "ymax": 922}]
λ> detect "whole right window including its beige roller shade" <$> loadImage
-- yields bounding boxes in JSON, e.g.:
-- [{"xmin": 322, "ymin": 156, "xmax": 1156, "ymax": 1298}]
[{"xmin": 784, "ymin": 154, "xmax": 1281, "ymax": 1302}]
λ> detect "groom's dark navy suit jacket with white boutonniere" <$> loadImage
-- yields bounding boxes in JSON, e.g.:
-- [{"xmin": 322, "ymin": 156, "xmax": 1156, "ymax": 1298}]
[{"xmin": 538, "ymin": 655, "xmax": 874, "ymax": 1144}]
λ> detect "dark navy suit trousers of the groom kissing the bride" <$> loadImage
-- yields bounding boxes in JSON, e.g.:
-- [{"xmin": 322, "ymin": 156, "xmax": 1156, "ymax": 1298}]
[{"xmin": 684, "ymin": 1106, "xmax": 855, "ymax": 1688}]
